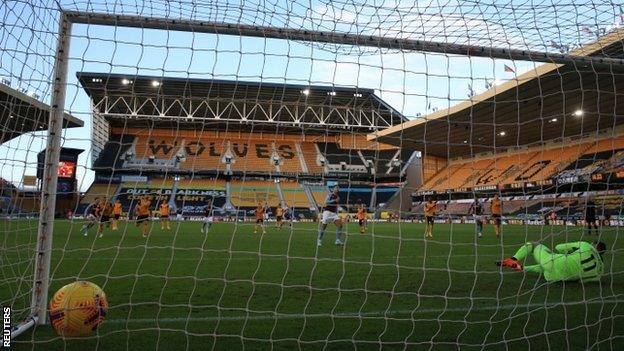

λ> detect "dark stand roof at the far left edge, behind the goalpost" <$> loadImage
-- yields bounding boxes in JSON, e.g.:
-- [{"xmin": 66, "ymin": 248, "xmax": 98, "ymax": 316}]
[{"xmin": 0, "ymin": 84, "xmax": 84, "ymax": 144}]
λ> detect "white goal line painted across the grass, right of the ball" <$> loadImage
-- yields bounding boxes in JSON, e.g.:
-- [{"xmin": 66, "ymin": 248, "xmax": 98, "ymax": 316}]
[{"xmin": 106, "ymin": 299, "xmax": 624, "ymax": 324}]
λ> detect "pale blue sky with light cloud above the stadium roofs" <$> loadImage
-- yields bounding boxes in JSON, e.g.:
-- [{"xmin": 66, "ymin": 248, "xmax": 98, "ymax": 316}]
[{"xmin": 0, "ymin": 0, "xmax": 622, "ymax": 191}]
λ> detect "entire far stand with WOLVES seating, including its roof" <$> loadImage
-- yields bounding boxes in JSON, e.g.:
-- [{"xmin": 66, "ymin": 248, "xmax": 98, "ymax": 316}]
[{"xmin": 77, "ymin": 72, "xmax": 414, "ymax": 223}]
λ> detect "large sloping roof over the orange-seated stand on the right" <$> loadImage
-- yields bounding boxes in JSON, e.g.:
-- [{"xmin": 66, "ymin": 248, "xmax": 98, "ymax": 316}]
[{"xmin": 368, "ymin": 28, "xmax": 624, "ymax": 158}]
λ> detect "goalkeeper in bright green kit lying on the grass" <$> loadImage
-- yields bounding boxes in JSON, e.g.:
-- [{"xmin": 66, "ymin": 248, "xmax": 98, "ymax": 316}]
[{"xmin": 496, "ymin": 241, "xmax": 607, "ymax": 282}]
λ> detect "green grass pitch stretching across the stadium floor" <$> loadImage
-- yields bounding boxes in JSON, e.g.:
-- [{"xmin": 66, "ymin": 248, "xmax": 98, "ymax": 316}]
[{"xmin": 0, "ymin": 221, "xmax": 624, "ymax": 350}]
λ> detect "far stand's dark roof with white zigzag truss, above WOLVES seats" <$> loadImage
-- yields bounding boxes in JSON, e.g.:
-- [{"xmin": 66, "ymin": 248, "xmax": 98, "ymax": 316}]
[{"xmin": 76, "ymin": 72, "xmax": 407, "ymax": 132}]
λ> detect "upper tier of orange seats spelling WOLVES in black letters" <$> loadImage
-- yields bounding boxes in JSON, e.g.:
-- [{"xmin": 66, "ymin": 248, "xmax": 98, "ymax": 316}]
[{"xmin": 94, "ymin": 128, "xmax": 336, "ymax": 174}]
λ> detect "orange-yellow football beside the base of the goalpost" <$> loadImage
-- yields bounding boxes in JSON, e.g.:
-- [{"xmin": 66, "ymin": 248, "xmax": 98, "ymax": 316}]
[{"xmin": 49, "ymin": 281, "xmax": 108, "ymax": 337}]
